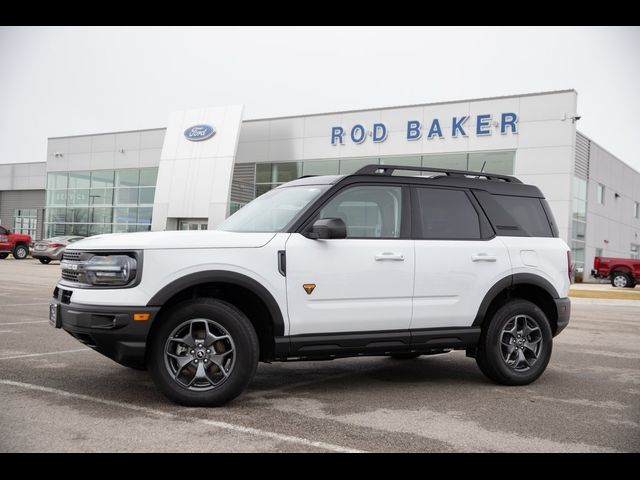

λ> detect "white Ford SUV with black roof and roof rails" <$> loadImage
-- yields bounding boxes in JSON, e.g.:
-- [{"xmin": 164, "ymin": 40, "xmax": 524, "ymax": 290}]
[{"xmin": 50, "ymin": 165, "xmax": 571, "ymax": 406}]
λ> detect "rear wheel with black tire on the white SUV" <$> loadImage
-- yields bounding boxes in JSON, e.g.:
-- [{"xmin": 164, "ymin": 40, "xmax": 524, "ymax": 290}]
[{"xmin": 476, "ymin": 299, "xmax": 553, "ymax": 385}]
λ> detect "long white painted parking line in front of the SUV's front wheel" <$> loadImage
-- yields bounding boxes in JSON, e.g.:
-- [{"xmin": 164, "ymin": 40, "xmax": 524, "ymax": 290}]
[{"xmin": 0, "ymin": 379, "xmax": 365, "ymax": 453}]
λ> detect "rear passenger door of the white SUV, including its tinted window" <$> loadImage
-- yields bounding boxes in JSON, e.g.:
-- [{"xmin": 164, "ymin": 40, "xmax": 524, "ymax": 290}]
[{"xmin": 411, "ymin": 186, "xmax": 511, "ymax": 330}]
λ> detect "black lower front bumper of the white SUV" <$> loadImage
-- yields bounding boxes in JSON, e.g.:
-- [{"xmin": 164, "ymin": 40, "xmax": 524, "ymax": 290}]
[{"xmin": 51, "ymin": 289, "xmax": 160, "ymax": 368}]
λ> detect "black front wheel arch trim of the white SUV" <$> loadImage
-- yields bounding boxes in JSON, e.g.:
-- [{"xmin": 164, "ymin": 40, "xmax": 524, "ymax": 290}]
[{"xmin": 147, "ymin": 270, "xmax": 284, "ymax": 361}]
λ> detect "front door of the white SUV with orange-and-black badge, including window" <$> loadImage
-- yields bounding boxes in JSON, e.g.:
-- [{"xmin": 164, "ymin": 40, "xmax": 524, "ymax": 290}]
[{"xmin": 286, "ymin": 184, "xmax": 414, "ymax": 335}]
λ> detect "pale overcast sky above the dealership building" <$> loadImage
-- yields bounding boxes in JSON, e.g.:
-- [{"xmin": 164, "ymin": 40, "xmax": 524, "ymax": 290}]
[{"xmin": 0, "ymin": 27, "xmax": 640, "ymax": 171}]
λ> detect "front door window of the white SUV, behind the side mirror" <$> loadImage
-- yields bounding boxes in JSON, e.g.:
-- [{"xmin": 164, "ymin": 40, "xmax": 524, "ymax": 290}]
[{"xmin": 318, "ymin": 185, "xmax": 402, "ymax": 238}]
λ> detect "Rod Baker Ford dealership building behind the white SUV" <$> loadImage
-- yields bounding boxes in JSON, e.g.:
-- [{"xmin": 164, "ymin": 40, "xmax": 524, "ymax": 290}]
[{"xmin": 0, "ymin": 90, "xmax": 640, "ymax": 281}]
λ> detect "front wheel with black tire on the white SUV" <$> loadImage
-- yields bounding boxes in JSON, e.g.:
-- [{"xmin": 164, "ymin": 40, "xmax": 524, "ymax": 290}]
[{"xmin": 146, "ymin": 298, "xmax": 259, "ymax": 407}]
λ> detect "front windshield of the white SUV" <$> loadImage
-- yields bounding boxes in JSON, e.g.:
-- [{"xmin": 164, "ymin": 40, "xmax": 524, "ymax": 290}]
[{"xmin": 219, "ymin": 185, "xmax": 329, "ymax": 232}]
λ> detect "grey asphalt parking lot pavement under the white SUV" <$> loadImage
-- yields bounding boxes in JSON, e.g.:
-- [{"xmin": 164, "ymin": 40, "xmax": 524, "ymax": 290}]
[{"xmin": 0, "ymin": 259, "xmax": 640, "ymax": 452}]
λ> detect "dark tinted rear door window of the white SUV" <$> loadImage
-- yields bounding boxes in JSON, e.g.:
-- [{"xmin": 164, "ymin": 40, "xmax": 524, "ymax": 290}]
[{"xmin": 416, "ymin": 188, "xmax": 480, "ymax": 240}]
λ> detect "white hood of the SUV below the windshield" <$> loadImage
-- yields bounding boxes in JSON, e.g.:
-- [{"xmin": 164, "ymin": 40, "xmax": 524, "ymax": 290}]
[{"xmin": 67, "ymin": 230, "xmax": 276, "ymax": 250}]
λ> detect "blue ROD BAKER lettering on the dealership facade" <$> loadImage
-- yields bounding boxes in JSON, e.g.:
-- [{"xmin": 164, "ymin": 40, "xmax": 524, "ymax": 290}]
[{"xmin": 331, "ymin": 112, "xmax": 518, "ymax": 145}]
